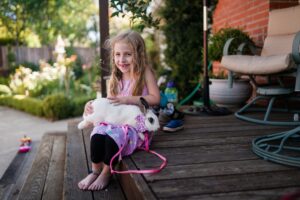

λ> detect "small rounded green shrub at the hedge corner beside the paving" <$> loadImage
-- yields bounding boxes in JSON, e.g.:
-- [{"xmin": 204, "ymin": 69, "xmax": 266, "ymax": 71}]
[{"xmin": 43, "ymin": 93, "xmax": 74, "ymax": 120}]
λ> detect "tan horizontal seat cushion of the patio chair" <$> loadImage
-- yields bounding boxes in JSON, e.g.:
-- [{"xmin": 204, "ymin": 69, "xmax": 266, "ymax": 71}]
[{"xmin": 221, "ymin": 54, "xmax": 295, "ymax": 75}]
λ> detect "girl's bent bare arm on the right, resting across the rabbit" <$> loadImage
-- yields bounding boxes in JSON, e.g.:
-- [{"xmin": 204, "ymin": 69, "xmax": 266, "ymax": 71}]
[{"xmin": 108, "ymin": 67, "xmax": 160, "ymax": 106}]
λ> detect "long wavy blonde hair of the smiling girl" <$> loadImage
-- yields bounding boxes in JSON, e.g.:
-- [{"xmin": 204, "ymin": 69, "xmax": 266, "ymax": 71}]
[{"xmin": 106, "ymin": 30, "xmax": 148, "ymax": 96}]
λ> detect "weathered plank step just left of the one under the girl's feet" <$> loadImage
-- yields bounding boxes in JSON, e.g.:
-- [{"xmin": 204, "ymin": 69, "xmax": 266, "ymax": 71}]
[{"xmin": 18, "ymin": 133, "xmax": 66, "ymax": 200}]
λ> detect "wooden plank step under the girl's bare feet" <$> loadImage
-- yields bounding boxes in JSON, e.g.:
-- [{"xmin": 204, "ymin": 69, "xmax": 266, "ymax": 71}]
[{"xmin": 63, "ymin": 121, "xmax": 126, "ymax": 200}]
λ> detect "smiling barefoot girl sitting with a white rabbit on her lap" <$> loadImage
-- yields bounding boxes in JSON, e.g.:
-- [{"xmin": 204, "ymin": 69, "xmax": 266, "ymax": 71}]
[{"xmin": 78, "ymin": 31, "xmax": 160, "ymax": 190}]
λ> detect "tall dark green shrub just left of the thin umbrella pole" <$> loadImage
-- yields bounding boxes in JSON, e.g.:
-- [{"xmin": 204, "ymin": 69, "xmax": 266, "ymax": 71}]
[{"xmin": 160, "ymin": 0, "xmax": 203, "ymax": 97}]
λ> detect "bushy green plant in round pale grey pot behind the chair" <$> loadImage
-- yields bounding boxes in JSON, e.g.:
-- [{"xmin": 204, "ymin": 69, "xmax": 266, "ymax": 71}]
[{"xmin": 208, "ymin": 28, "xmax": 254, "ymax": 107}]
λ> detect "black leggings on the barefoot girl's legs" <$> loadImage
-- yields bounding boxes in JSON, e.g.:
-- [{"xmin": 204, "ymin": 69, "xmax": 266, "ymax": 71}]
[{"xmin": 91, "ymin": 134, "xmax": 119, "ymax": 165}]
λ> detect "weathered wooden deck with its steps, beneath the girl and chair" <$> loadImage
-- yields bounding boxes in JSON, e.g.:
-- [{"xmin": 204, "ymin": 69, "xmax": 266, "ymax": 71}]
[{"xmin": 0, "ymin": 112, "xmax": 300, "ymax": 200}]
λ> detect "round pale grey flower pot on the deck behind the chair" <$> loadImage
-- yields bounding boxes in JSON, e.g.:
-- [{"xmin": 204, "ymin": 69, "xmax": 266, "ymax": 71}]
[{"xmin": 209, "ymin": 79, "xmax": 252, "ymax": 107}]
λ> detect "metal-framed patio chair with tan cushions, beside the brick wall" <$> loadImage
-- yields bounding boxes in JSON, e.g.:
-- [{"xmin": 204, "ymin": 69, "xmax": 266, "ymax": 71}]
[{"xmin": 221, "ymin": 6, "xmax": 300, "ymax": 125}]
